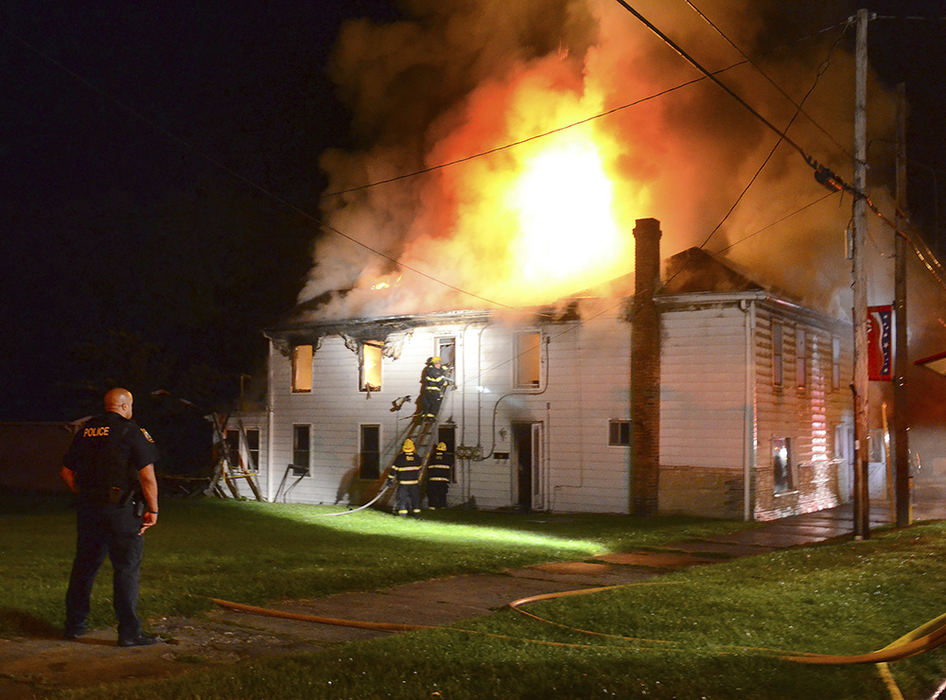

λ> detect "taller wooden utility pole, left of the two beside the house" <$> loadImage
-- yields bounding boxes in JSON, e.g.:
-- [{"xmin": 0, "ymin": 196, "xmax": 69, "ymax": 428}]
[{"xmin": 853, "ymin": 9, "xmax": 870, "ymax": 539}]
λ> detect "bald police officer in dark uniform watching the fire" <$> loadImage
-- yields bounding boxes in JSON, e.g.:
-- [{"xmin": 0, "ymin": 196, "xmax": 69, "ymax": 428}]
[{"xmin": 60, "ymin": 388, "xmax": 160, "ymax": 647}]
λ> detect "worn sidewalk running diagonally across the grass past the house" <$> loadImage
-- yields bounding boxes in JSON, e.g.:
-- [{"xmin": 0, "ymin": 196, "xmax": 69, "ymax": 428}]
[{"xmin": 0, "ymin": 502, "xmax": 946, "ymax": 699}]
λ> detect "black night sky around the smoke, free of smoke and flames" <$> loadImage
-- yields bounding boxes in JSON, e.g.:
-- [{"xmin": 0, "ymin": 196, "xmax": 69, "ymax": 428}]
[{"xmin": 0, "ymin": 0, "xmax": 946, "ymax": 421}]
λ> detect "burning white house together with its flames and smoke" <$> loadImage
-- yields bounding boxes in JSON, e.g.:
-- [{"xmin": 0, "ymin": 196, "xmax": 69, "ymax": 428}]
[{"xmin": 216, "ymin": 0, "xmax": 944, "ymax": 519}]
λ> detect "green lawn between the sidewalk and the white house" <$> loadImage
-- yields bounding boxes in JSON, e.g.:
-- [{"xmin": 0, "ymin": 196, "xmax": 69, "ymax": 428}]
[{"xmin": 0, "ymin": 499, "xmax": 743, "ymax": 636}]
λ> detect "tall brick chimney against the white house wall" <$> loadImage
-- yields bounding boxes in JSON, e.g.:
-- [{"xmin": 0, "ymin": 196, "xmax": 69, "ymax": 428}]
[{"xmin": 630, "ymin": 219, "xmax": 660, "ymax": 516}]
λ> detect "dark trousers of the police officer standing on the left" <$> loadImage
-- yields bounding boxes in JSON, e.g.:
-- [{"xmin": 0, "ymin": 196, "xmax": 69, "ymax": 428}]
[{"xmin": 66, "ymin": 503, "xmax": 144, "ymax": 639}]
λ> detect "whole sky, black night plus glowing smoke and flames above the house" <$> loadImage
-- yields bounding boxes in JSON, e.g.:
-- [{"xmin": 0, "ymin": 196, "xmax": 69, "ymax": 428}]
[{"xmin": 0, "ymin": 0, "xmax": 946, "ymax": 420}]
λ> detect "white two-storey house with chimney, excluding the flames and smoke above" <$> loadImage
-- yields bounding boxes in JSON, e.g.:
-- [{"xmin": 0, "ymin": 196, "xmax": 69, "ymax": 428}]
[{"xmin": 229, "ymin": 219, "xmax": 853, "ymax": 520}]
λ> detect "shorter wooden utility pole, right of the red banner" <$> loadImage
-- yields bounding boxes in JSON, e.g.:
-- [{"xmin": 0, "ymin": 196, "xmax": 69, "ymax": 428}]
[{"xmin": 892, "ymin": 83, "xmax": 910, "ymax": 527}]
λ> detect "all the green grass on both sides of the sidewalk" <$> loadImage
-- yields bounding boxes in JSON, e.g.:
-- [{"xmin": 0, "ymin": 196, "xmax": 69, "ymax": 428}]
[{"xmin": 0, "ymin": 494, "xmax": 946, "ymax": 700}]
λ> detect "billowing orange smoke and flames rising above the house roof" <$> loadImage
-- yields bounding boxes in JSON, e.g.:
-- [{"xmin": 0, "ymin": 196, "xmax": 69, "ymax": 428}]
[{"xmin": 299, "ymin": 0, "xmax": 894, "ymax": 317}]
